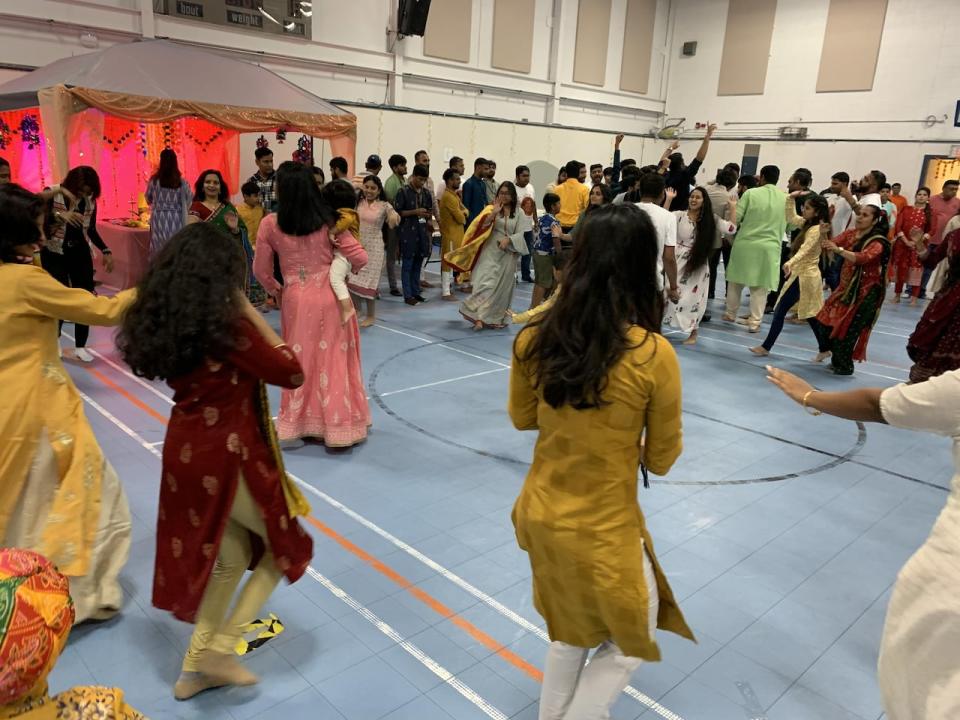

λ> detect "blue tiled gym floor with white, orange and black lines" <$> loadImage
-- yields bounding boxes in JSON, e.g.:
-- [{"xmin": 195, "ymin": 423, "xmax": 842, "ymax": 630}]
[{"xmin": 51, "ymin": 270, "xmax": 952, "ymax": 720}]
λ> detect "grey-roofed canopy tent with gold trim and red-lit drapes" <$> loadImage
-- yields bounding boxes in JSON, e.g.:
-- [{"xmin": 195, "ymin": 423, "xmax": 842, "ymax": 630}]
[{"xmin": 0, "ymin": 40, "xmax": 357, "ymax": 217}]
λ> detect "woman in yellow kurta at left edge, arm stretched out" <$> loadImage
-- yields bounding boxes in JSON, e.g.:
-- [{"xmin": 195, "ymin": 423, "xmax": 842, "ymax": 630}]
[{"xmin": 0, "ymin": 185, "xmax": 135, "ymax": 622}]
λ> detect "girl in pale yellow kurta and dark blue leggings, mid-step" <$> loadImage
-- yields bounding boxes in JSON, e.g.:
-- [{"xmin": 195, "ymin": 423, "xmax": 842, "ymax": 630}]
[{"xmin": 750, "ymin": 190, "xmax": 830, "ymax": 357}]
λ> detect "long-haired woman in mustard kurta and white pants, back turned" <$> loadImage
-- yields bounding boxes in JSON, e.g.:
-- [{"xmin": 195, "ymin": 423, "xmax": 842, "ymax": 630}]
[{"xmin": 509, "ymin": 204, "xmax": 693, "ymax": 719}]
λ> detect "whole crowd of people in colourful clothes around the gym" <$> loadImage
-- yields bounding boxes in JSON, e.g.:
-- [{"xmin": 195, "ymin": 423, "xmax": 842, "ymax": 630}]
[{"xmin": 0, "ymin": 131, "xmax": 960, "ymax": 720}]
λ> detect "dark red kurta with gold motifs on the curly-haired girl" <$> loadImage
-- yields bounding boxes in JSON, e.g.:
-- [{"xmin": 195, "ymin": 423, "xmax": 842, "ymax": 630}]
[{"xmin": 153, "ymin": 320, "xmax": 313, "ymax": 622}]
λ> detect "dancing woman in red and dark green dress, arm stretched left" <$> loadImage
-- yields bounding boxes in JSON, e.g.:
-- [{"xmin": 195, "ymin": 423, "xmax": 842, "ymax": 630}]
[{"xmin": 816, "ymin": 205, "xmax": 890, "ymax": 375}]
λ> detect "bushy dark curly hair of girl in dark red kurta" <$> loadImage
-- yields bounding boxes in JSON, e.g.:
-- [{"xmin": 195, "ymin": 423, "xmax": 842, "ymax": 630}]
[{"xmin": 117, "ymin": 223, "xmax": 246, "ymax": 380}]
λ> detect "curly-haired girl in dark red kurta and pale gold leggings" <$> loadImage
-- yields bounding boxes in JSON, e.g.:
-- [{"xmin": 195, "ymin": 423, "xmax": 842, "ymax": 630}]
[{"xmin": 119, "ymin": 224, "xmax": 313, "ymax": 700}]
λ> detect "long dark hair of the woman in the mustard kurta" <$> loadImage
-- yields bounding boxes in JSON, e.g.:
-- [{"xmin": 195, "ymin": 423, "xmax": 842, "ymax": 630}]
[{"xmin": 514, "ymin": 203, "xmax": 663, "ymax": 409}]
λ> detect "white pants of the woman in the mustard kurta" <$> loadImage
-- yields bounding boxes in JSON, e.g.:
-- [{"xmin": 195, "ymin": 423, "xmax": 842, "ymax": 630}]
[{"xmin": 540, "ymin": 550, "xmax": 660, "ymax": 720}]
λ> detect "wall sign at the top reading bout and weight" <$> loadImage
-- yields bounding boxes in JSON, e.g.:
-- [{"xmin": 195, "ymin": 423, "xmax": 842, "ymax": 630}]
[{"xmin": 153, "ymin": 0, "xmax": 313, "ymax": 38}]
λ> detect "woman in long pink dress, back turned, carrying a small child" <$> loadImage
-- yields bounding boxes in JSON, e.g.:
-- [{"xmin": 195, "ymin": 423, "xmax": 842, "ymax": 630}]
[{"xmin": 253, "ymin": 162, "xmax": 370, "ymax": 447}]
